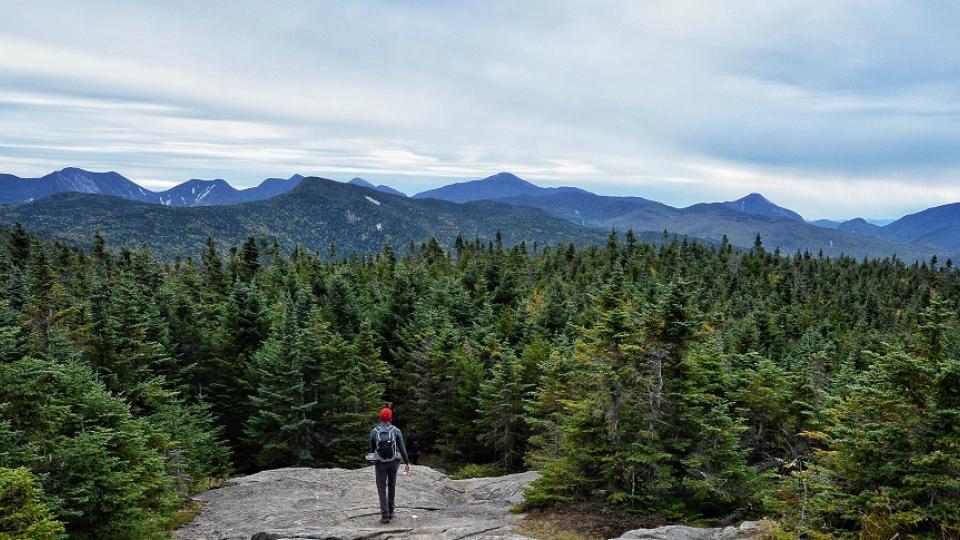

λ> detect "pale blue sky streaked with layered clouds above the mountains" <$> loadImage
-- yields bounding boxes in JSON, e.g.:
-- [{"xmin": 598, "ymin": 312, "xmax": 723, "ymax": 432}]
[{"xmin": 0, "ymin": 0, "xmax": 960, "ymax": 219}]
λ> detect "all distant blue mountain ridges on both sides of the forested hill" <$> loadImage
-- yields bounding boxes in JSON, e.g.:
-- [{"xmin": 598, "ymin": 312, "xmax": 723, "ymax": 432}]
[{"xmin": 0, "ymin": 167, "xmax": 960, "ymax": 254}]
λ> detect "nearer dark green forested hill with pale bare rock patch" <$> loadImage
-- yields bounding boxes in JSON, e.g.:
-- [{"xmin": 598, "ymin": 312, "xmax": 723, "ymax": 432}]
[{"xmin": 0, "ymin": 174, "xmax": 604, "ymax": 258}]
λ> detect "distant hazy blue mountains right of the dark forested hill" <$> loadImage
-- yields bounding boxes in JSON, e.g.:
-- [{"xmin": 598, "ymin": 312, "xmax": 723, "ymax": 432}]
[{"xmin": 414, "ymin": 173, "xmax": 960, "ymax": 260}]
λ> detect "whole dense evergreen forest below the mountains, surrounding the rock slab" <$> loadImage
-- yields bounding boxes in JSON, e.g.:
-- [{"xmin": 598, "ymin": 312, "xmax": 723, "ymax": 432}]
[{"xmin": 0, "ymin": 223, "xmax": 960, "ymax": 538}]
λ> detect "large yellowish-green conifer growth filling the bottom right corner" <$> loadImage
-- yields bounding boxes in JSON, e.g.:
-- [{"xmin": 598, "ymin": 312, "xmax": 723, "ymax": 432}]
[{"xmin": 780, "ymin": 300, "xmax": 960, "ymax": 537}]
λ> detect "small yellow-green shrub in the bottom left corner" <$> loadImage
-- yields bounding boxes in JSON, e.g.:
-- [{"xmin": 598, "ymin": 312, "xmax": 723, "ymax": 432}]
[{"xmin": 0, "ymin": 467, "xmax": 64, "ymax": 540}]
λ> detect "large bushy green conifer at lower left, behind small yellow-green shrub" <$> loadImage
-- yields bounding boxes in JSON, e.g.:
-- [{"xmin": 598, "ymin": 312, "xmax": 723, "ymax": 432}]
[{"xmin": 0, "ymin": 358, "xmax": 178, "ymax": 538}]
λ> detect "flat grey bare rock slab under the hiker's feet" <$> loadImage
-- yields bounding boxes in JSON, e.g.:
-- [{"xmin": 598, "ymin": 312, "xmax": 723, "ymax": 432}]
[{"xmin": 174, "ymin": 466, "xmax": 536, "ymax": 540}]
